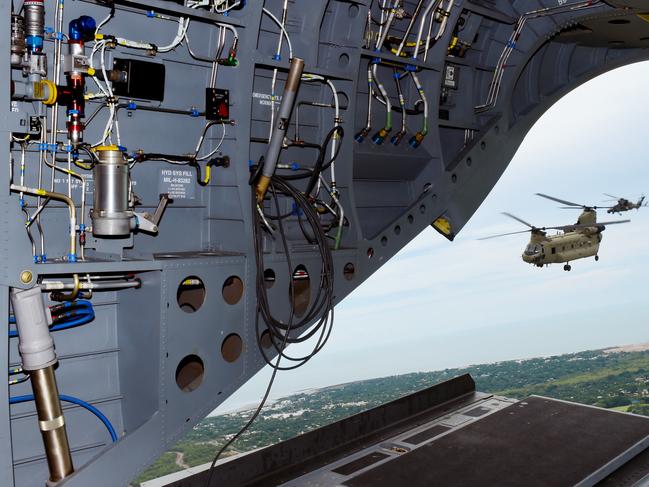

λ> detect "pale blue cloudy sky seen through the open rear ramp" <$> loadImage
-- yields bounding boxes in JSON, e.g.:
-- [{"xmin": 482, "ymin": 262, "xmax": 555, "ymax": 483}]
[{"xmin": 217, "ymin": 63, "xmax": 649, "ymax": 411}]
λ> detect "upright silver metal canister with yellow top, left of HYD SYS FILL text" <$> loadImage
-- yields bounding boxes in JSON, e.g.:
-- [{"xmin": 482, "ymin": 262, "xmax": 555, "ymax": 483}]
[{"xmin": 90, "ymin": 145, "xmax": 135, "ymax": 237}]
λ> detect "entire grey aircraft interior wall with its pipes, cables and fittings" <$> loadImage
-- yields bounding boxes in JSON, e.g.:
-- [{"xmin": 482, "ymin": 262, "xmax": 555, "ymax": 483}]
[{"xmin": 0, "ymin": 0, "xmax": 649, "ymax": 486}]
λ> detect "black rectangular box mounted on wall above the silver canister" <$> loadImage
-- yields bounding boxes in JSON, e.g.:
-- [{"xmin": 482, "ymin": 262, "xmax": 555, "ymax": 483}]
[{"xmin": 113, "ymin": 58, "xmax": 165, "ymax": 101}]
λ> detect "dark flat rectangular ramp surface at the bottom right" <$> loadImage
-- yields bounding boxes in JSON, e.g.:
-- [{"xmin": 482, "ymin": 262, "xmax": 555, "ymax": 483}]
[{"xmin": 344, "ymin": 397, "xmax": 649, "ymax": 487}]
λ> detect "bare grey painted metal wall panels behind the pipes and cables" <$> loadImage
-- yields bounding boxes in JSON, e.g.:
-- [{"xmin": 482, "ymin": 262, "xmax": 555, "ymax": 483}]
[{"xmin": 0, "ymin": 0, "xmax": 649, "ymax": 486}]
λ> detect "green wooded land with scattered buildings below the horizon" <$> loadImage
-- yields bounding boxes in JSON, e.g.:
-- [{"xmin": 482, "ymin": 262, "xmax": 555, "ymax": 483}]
[{"xmin": 130, "ymin": 350, "xmax": 649, "ymax": 483}]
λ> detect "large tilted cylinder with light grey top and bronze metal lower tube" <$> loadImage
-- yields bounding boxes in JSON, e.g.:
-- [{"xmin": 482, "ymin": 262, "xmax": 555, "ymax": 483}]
[{"xmin": 11, "ymin": 286, "xmax": 74, "ymax": 484}]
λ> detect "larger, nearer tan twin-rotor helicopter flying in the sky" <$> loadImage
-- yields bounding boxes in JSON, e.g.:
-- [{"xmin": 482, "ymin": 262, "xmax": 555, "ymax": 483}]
[{"xmin": 480, "ymin": 193, "xmax": 630, "ymax": 271}]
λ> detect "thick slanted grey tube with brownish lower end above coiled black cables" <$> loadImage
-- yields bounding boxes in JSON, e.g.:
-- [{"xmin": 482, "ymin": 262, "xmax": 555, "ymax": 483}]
[{"xmin": 256, "ymin": 57, "xmax": 304, "ymax": 202}]
